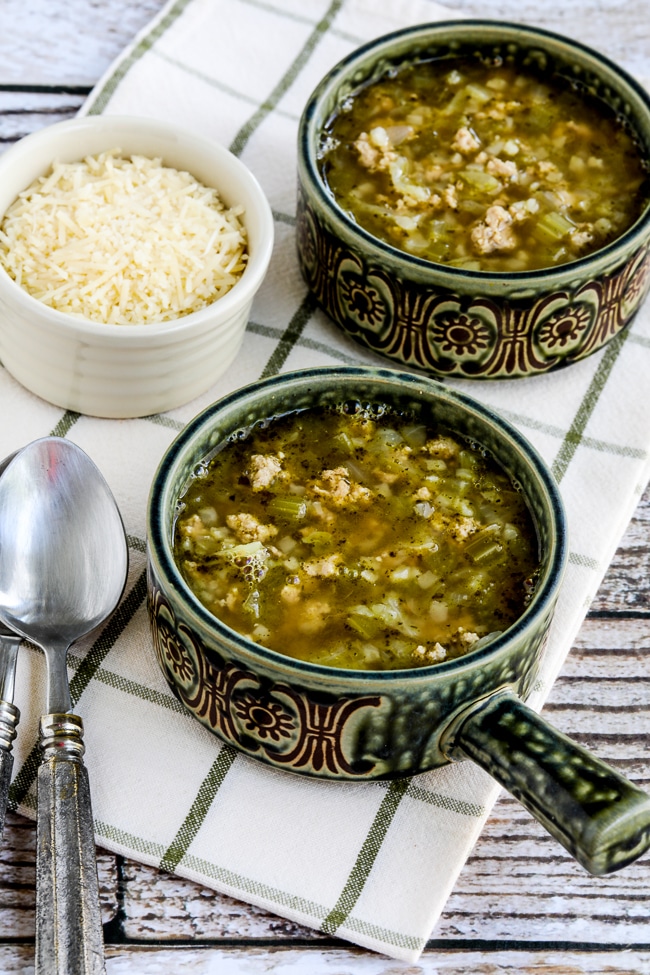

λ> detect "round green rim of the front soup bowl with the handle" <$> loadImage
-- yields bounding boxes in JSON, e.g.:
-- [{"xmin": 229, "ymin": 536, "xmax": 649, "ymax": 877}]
[{"xmin": 146, "ymin": 366, "xmax": 568, "ymax": 690}]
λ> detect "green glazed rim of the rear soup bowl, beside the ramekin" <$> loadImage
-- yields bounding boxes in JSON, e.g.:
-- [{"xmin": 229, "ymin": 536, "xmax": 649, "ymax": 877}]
[{"xmin": 298, "ymin": 18, "xmax": 650, "ymax": 289}]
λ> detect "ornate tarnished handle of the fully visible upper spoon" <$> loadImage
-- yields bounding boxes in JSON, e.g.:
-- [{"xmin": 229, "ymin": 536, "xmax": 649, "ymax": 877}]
[{"xmin": 36, "ymin": 714, "xmax": 105, "ymax": 975}]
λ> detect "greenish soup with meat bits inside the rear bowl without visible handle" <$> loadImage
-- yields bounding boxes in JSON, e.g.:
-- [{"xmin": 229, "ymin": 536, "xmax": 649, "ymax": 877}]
[{"xmin": 319, "ymin": 58, "xmax": 648, "ymax": 271}]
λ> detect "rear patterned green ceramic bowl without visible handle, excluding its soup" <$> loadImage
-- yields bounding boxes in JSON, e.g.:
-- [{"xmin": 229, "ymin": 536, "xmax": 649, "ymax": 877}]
[{"xmin": 297, "ymin": 20, "xmax": 650, "ymax": 379}]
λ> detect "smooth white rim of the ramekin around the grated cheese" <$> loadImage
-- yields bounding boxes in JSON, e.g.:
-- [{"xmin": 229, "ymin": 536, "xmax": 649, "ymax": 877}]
[{"xmin": 0, "ymin": 114, "xmax": 275, "ymax": 336}]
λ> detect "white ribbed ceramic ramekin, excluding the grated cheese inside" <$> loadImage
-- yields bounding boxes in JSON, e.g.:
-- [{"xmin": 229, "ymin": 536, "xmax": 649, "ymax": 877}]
[{"xmin": 0, "ymin": 116, "xmax": 273, "ymax": 417}]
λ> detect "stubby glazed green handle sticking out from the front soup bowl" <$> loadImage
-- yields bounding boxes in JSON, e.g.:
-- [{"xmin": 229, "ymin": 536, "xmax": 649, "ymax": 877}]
[{"xmin": 441, "ymin": 692, "xmax": 650, "ymax": 876}]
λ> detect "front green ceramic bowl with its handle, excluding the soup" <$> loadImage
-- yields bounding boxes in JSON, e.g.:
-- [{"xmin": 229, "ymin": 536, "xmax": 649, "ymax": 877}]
[{"xmin": 147, "ymin": 367, "xmax": 650, "ymax": 874}]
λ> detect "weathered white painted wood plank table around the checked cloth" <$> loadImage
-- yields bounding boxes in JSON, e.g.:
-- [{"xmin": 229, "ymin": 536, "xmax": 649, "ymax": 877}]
[{"xmin": 0, "ymin": 0, "xmax": 650, "ymax": 975}]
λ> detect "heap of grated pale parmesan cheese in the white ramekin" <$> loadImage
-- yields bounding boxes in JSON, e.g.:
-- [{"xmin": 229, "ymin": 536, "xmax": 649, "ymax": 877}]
[{"xmin": 0, "ymin": 149, "xmax": 248, "ymax": 325}]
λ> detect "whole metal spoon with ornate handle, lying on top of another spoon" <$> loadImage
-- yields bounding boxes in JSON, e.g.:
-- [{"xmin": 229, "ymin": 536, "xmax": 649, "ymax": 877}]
[{"xmin": 0, "ymin": 437, "xmax": 128, "ymax": 975}]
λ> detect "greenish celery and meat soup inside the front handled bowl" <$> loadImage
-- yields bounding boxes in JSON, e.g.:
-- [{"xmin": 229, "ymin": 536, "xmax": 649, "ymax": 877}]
[{"xmin": 174, "ymin": 405, "xmax": 538, "ymax": 670}]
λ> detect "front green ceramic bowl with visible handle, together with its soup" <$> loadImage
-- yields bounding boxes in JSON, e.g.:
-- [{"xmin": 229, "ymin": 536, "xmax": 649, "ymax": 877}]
[{"xmin": 147, "ymin": 368, "xmax": 650, "ymax": 873}]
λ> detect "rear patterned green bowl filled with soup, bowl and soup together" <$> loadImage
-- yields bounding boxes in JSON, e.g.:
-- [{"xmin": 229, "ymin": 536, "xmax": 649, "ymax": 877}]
[{"xmin": 297, "ymin": 21, "xmax": 650, "ymax": 379}]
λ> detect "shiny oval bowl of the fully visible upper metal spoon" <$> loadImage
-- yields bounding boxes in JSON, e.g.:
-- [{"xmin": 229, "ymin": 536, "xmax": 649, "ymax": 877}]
[{"xmin": 0, "ymin": 437, "xmax": 127, "ymax": 696}]
